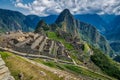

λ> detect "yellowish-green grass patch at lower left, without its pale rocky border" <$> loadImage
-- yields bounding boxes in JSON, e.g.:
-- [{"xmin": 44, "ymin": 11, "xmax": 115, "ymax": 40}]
[{"xmin": 0, "ymin": 52, "xmax": 63, "ymax": 80}]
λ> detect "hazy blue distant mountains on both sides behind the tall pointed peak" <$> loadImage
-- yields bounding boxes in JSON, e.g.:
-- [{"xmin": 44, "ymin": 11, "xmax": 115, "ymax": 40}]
[{"xmin": 0, "ymin": 9, "xmax": 120, "ymax": 54}]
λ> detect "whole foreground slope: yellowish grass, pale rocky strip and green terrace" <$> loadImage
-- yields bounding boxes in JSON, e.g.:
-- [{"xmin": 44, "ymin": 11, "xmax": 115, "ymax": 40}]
[{"xmin": 0, "ymin": 51, "xmax": 116, "ymax": 80}]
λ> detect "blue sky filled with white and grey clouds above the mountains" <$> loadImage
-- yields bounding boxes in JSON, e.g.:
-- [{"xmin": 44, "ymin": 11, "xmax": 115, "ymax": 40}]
[{"xmin": 0, "ymin": 0, "xmax": 120, "ymax": 16}]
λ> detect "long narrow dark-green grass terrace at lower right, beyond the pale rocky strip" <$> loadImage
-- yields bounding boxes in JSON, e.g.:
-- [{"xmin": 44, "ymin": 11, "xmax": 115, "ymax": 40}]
[{"xmin": 34, "ymin": 59, "xmax": 115, "ymax": 80}]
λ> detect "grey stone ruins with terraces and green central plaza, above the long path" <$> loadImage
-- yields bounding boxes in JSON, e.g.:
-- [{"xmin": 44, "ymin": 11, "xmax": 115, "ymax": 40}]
[{"xmin": 0, "ymin": 32, "xmax": 95, "ymax": 67}]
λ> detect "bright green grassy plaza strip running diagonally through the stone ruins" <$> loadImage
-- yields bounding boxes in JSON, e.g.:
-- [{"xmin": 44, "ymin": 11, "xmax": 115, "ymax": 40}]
[{"xmin": 46, "ymin": 31, "xmax": 74, "ymax": 50}]
